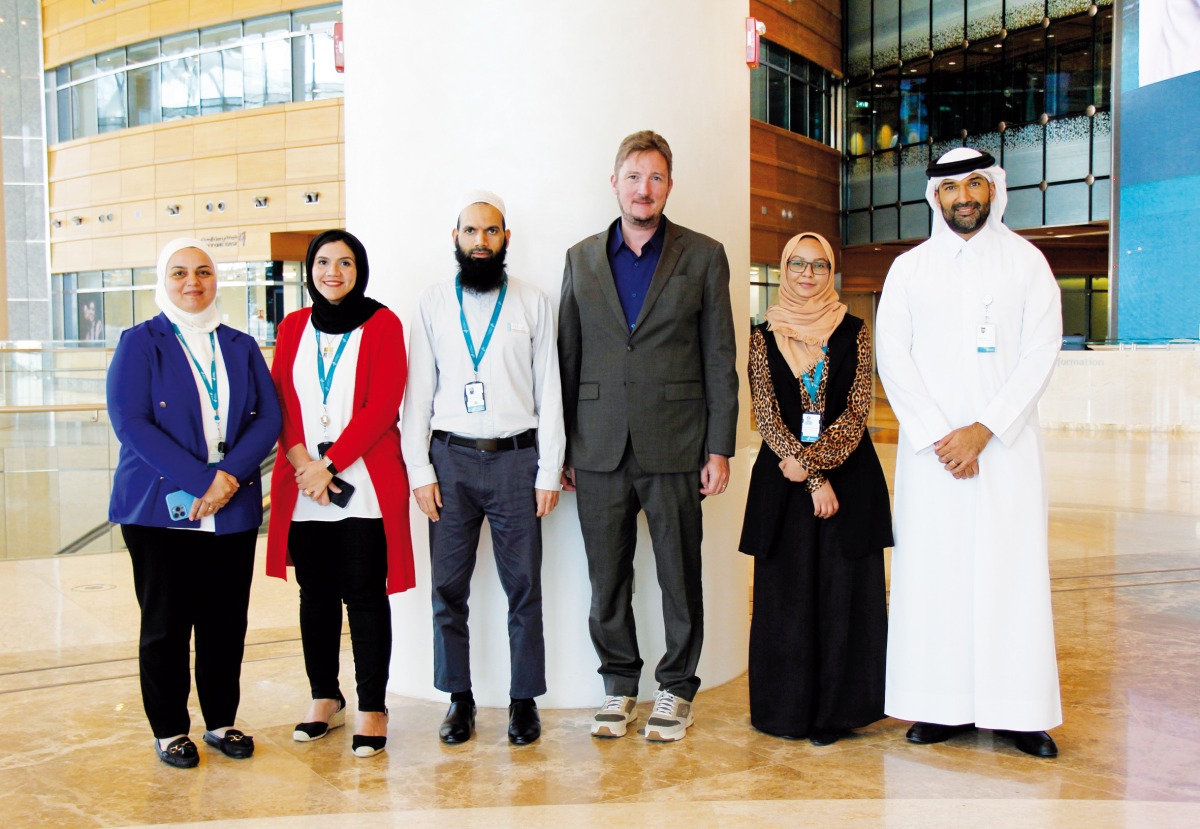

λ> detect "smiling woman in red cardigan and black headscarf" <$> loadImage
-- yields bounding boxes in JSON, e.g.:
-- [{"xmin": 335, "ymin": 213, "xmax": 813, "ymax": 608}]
[{"xmin": 266, "ymin": 230, "xmax": 414, "ymax": 757}]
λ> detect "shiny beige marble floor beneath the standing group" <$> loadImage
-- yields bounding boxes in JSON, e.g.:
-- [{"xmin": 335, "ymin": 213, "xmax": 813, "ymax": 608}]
[{"xmin": 0, "ymin": 412, "xmax": 1200, "ymax": 829}]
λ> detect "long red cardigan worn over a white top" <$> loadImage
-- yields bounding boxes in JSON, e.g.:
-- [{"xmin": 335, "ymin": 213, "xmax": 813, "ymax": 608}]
[{"xmin": 266, "ymin": 308, "xmax": 416, "ymax": 594}]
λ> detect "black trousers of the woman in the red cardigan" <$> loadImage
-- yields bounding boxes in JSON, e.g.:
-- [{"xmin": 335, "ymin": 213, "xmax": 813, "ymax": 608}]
[{"xmin": 288, "ymin": 518, "xmax": 391, "ymax": 711}]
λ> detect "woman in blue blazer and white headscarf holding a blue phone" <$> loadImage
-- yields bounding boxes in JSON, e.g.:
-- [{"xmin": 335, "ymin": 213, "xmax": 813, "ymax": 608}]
[{"xmin": 108, "ymin": 239, "xmax": 282, "ymax": 768}]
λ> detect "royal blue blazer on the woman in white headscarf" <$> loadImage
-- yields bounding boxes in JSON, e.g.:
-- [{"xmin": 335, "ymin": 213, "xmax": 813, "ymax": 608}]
[{"xmin": 108, "ymin": 314, "xmax": 283, "ymax": 535}]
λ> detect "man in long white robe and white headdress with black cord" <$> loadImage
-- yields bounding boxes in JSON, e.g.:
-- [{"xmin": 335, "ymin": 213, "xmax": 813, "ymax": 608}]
[{"xmin": 876, "ymin": 148, "xmax": 1062, "ymax": 757}]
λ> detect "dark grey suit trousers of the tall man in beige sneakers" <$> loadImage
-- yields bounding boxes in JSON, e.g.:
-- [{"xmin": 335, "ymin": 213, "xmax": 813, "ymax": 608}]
[{"xmin": 575, "ymin": 446, "xmax": 704, "ymax": 701}]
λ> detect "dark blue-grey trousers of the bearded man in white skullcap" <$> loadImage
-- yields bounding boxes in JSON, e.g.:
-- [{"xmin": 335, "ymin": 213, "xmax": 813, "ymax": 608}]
[{"xmin": 430, "ymin": 439, "xmax": 546, "ymax": 699}]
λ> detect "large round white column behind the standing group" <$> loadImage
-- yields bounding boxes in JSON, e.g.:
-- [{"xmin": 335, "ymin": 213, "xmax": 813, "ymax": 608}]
[{"xmin": 344, "ymin": 0, "xmax": 750, "ymax": 708}]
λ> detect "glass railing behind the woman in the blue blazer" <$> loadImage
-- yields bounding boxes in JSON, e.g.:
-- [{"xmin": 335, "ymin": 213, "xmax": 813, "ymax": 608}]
[{"xmin": 0, "ymin": 343, "xmax": 274, "ymax": 559}]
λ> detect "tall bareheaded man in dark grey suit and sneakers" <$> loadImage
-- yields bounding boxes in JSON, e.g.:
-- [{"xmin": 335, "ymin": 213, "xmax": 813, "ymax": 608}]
[{"xmin": 558, "ymin": 130, "xmax": 738, "ymax": 741}]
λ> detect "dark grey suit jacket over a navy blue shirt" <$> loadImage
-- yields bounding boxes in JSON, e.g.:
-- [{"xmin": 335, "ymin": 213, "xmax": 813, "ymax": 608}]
[{"xmin": 558, "ymin": 217, "xmax": 738, "ymax": 473}]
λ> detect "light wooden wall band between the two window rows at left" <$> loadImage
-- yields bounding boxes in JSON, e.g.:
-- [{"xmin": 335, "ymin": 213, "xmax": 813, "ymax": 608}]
[{"xmin": 48, "ymin": 99, "xmax": 346, "ymax": 272}]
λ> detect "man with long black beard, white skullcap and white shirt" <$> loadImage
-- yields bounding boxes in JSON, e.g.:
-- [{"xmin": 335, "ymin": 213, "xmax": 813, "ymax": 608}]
[{"xmin": 401, "ymin": 191, "xmax": 566, "ymax": 745}]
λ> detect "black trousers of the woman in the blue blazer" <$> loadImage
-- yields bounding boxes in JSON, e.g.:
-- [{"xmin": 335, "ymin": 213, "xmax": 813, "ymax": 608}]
[{"xmin": 121, "ymin": 524, "xmax": 258, "ymax": 738}]
